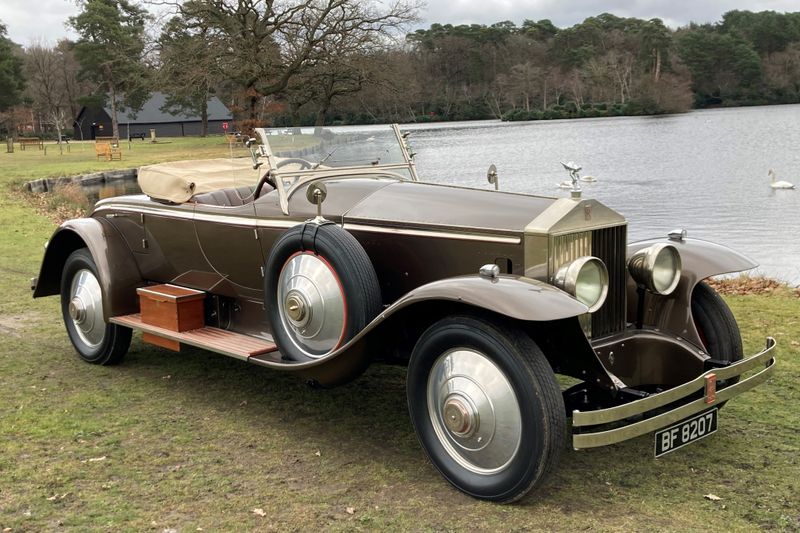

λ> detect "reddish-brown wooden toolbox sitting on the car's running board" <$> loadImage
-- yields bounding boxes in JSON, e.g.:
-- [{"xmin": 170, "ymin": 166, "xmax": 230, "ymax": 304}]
[{"xmin": 136, "ymin": 284, "xmax": 206, "ymax": 350}]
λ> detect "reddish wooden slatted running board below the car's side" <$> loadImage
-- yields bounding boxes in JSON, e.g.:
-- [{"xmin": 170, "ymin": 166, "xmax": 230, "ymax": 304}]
[{"xmin": 111, "ymin": 313, "xmax": 278, "ymax": 360}]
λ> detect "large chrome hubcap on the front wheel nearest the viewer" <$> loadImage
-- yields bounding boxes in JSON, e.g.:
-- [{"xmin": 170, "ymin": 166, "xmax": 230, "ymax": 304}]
[{"xmin": 427, "ymin": 348, "xmax": 522, "ymax": 474}]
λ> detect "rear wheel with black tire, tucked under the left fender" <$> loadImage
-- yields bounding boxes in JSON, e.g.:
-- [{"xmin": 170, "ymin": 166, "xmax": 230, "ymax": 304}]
[{"xmin": 61, "ymin": 248, "xmax": 132, "ymax": 365}]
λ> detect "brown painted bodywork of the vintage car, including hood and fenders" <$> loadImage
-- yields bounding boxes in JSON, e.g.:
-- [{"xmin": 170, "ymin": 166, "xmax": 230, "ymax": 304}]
[{"xmin": 34, "ymin": 172, "xmax": 764, "ymax": 388}]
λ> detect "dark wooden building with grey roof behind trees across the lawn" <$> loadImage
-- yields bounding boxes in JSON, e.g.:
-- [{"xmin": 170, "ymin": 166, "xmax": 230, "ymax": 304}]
[{"xmin": 73, "ymin": 93, "xmax": 233, "ymax": 140}]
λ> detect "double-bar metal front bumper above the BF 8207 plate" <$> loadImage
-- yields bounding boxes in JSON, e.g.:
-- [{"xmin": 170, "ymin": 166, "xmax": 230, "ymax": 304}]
[{"xmin": 572, "ymin": 337, "xmax": 776, "ymax": 450}]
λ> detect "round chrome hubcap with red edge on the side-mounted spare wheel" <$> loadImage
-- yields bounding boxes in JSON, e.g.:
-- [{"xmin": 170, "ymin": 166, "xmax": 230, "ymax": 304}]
[{"xmin": 278, "ymin": 253, "xmax": 346, "ymax": 358}]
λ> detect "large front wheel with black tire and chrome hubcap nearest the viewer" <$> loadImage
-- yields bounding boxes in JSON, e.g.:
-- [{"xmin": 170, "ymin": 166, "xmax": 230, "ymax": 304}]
[{"xmin": 407, "ymin": 316, "xmax": 567, "ymax": 503}]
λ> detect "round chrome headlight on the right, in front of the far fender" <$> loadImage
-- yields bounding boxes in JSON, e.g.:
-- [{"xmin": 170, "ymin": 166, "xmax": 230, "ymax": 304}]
[{"xmin": 628, "ymin": 243, "xmax": 681, "ymax": 296}]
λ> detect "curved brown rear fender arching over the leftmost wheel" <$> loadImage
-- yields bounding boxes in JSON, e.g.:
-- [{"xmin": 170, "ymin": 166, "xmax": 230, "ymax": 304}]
[{"xmin": 33, "ymin": 218, "xmax": 143, "ymax": 320}]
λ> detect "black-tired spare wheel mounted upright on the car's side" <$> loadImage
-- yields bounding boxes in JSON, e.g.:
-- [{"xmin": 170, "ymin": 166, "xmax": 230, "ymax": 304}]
[{"xmin": 264, "ymin": 223, "xmax": 382, "ymax": 361}]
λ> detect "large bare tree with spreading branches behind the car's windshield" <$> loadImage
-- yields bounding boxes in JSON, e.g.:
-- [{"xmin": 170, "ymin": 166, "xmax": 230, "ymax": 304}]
[{"xmin": 151, "ymin": 0, "xmax": 417, "ymax": 121}]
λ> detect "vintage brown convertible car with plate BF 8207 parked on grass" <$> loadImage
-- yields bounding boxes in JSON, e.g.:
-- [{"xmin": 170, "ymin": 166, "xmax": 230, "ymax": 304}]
[{"xmin": 33, "ymin": 126, "xmax": 775, "ymax": 502}]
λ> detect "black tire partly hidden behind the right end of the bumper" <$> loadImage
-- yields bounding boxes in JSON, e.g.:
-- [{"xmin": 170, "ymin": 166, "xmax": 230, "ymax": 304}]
[{"xmin": 692, "ymin": 282, "xmax": 744, "ymax": 388}]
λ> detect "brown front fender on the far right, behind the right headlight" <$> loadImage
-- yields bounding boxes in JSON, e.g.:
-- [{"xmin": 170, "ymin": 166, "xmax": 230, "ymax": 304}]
[{"xmin": 628, "ymin": 238, "xmax": 758, "ymax": 346}]
